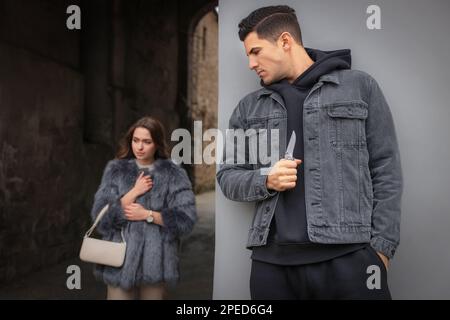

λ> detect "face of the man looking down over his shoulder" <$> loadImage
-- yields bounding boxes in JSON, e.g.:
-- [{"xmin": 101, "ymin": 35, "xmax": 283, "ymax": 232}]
[{"xmin": 244, "ymin": 32, "xmax": 286, "ymax": 85}]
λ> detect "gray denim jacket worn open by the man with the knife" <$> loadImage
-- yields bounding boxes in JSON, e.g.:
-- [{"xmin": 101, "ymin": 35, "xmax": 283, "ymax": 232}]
[{"xmin": 217, "ymin": 70, "xmax": 403, "ymax": 258}]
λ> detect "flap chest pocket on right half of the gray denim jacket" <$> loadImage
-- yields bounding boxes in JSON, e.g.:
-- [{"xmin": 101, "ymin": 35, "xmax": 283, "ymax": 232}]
[{"xmin": 327, "ymin": 101, "xmax": 368, "ymax": 148}]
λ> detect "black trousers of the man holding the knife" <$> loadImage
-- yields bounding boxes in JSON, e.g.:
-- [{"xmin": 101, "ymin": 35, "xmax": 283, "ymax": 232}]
[{"xmin": 250, "ymin": 245, "xmax": 391, "ymax": 300}]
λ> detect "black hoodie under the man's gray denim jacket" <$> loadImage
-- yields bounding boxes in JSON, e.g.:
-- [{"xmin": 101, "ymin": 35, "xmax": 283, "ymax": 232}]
[{"xmin": 252, "ymin": 48, "xmax": 368, "ymax": 265}]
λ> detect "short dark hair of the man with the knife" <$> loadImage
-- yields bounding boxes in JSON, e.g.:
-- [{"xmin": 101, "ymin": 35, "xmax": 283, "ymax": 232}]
[{"xmin": 239, "ymin": 6, "xmax": 303, "ymax": 45}]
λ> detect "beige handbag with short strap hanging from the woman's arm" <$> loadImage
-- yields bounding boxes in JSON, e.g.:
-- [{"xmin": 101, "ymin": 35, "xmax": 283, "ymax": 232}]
[{"xmin": 80, "ymin": 205, "xmax": 127, "ymax": 267}]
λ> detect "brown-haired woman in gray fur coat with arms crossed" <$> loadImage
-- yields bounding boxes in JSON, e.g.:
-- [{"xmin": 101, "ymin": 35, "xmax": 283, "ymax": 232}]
[{"xmin": 91, "ymin": 117, "xmax": 197, "ymax": 299}]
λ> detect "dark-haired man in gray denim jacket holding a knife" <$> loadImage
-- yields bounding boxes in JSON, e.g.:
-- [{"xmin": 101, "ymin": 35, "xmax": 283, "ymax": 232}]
[{"xmin": 217, "ymin": 6, "xmax": 402, "ymax": 299}]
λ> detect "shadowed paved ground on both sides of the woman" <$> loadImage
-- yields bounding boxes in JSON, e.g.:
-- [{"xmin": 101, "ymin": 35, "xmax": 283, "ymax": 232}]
[{"xmin": 0, "ymin": 192, "xmax": 215, "ymax": 300}]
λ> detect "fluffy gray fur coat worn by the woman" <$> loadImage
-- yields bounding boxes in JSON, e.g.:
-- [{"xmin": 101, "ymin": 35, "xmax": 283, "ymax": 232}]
[{"xmin": 91, "ymin": 159, "xmax": 197, "ymax": 289}]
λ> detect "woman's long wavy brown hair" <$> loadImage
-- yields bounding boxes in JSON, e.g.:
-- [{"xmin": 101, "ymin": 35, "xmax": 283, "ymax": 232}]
[{"xmin": 116, "ymin": 117, "xmax": 169, "ymax": 160}]
